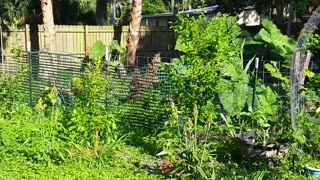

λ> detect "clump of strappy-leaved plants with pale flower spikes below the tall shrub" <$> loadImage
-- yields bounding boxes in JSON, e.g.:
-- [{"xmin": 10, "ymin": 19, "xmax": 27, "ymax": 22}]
[{"xmin": 158, "ymin": 103, "xmax": 216, "ymax": 179}]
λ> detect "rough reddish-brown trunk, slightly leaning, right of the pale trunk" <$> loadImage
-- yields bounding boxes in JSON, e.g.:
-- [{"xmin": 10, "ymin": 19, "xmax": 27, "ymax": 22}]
[{"xmin": 127, "ymin": 0, "xmax": 142, "ymax": 67}]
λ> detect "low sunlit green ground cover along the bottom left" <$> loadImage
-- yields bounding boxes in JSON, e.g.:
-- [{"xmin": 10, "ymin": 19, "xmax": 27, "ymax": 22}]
[{"xmin": 0, "ymin": 148, "xmax": 163, "ymax": 180}]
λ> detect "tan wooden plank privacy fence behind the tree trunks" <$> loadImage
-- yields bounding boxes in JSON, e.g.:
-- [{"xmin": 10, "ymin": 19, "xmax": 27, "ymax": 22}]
[{"xmin": 2, "ymin": 25, "xmax": 175, "ymax": 53}]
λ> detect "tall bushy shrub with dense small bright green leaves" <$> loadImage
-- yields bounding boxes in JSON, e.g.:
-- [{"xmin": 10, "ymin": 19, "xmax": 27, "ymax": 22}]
[{"xmin": 168, "ymin": 14, "xmax": 248, "ymax": 115}]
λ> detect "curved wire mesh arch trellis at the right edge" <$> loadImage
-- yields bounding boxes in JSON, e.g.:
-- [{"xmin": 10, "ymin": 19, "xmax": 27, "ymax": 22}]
[{"xmin": 290, "ymin": 6, "xmax": 320, "ymax": 129}]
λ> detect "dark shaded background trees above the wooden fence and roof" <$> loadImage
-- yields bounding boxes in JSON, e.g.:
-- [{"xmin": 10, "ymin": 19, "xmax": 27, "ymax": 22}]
[{"xmin": 0, "ymin": 0, "xmax": 320, "ymax": 25}]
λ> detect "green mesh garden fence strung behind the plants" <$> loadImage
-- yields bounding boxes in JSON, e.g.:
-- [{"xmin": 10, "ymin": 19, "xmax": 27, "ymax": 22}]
[{"xmin": 0, "ymin": 51, "xmax": 298, "ymax": 128}]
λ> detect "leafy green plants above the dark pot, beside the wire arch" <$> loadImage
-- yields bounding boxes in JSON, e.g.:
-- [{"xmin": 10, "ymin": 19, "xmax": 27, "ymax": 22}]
[{"xmin": 243, "ymin": 61, "xmax": 294, "ymax": 142}]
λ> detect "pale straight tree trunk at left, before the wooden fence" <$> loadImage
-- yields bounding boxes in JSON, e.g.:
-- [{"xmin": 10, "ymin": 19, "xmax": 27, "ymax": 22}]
[{"xmin": 41, "ymin": 0, "xmax": 55, "ymax": 51}]
